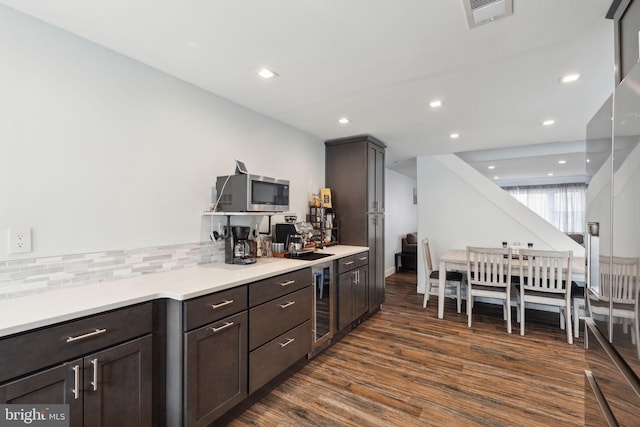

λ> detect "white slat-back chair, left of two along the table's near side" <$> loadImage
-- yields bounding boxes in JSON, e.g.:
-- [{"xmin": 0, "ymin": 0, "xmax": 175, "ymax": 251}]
[{"xmin": 467, "ymin": 246, "xmax": 511, "ymax": 333}]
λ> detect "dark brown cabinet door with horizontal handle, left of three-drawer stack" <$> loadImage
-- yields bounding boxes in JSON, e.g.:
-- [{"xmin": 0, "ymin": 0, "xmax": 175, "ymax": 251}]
[{"xmin": 184, "ymin": 311, "xmax": 248, "ymax": 427}]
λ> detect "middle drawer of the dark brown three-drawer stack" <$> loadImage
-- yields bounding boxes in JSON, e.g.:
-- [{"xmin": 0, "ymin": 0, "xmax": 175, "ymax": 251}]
[{"xmin": 249, "ymin": 285, "xmax": 313, "ymax": 350}]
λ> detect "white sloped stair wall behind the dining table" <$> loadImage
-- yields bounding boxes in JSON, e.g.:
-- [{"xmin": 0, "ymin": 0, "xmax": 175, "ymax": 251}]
[{"xmin": 417, "ymin": 154, "xmax": 584, "ymax": 292}]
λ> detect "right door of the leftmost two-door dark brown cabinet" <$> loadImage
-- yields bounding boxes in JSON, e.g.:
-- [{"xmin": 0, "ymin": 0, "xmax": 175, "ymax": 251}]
[{"xmin": 84, "ymin": 335, "xmax": 152, "ymax": 427}]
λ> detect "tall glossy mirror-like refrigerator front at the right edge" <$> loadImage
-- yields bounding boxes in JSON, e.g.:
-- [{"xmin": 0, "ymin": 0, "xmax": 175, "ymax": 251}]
[{"xmin": 585, "ymin": 56, "xmax": 640, "ymax": 426}]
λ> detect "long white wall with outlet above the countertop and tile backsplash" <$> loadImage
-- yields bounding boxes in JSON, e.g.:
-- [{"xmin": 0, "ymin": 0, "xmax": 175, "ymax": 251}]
[{"xmin": 0, "ymin": 6, "xmax": 324, "ymax": 260}]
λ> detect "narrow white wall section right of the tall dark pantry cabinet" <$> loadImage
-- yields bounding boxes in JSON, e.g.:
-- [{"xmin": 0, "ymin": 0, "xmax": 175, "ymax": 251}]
[{"xmin": 384, "ymin": 169, "xmax": 418, "ymax": 276}]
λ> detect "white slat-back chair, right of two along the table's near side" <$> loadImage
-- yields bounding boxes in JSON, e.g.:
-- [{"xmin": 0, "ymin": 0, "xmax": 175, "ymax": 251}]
[{"xmin": 515, "ymin": 249, "xmax": 573, "ymax": 344}]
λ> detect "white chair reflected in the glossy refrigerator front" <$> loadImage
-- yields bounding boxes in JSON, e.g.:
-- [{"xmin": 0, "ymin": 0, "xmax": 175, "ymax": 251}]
[{"xmin": 590, "ymin": 256, "xmax": 640, "ymax": 357}]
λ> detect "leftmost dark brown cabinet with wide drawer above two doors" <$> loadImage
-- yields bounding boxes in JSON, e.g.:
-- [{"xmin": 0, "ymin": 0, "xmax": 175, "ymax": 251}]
[{"xmin": 0, "ymin": 304, "xmax": 153, "ymax": 426}]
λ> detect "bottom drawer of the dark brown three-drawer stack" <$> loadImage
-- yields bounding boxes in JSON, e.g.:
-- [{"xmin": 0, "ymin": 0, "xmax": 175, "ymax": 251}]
[{"xmin": 249, "ymin": 320, "xmax": 311, "ymax": 393}]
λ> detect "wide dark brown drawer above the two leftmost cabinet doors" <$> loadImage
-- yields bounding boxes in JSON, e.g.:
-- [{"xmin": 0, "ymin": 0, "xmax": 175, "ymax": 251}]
[{"xmin": 0, "ymin": 303, "xmax": 153, "ymax": 382}]
